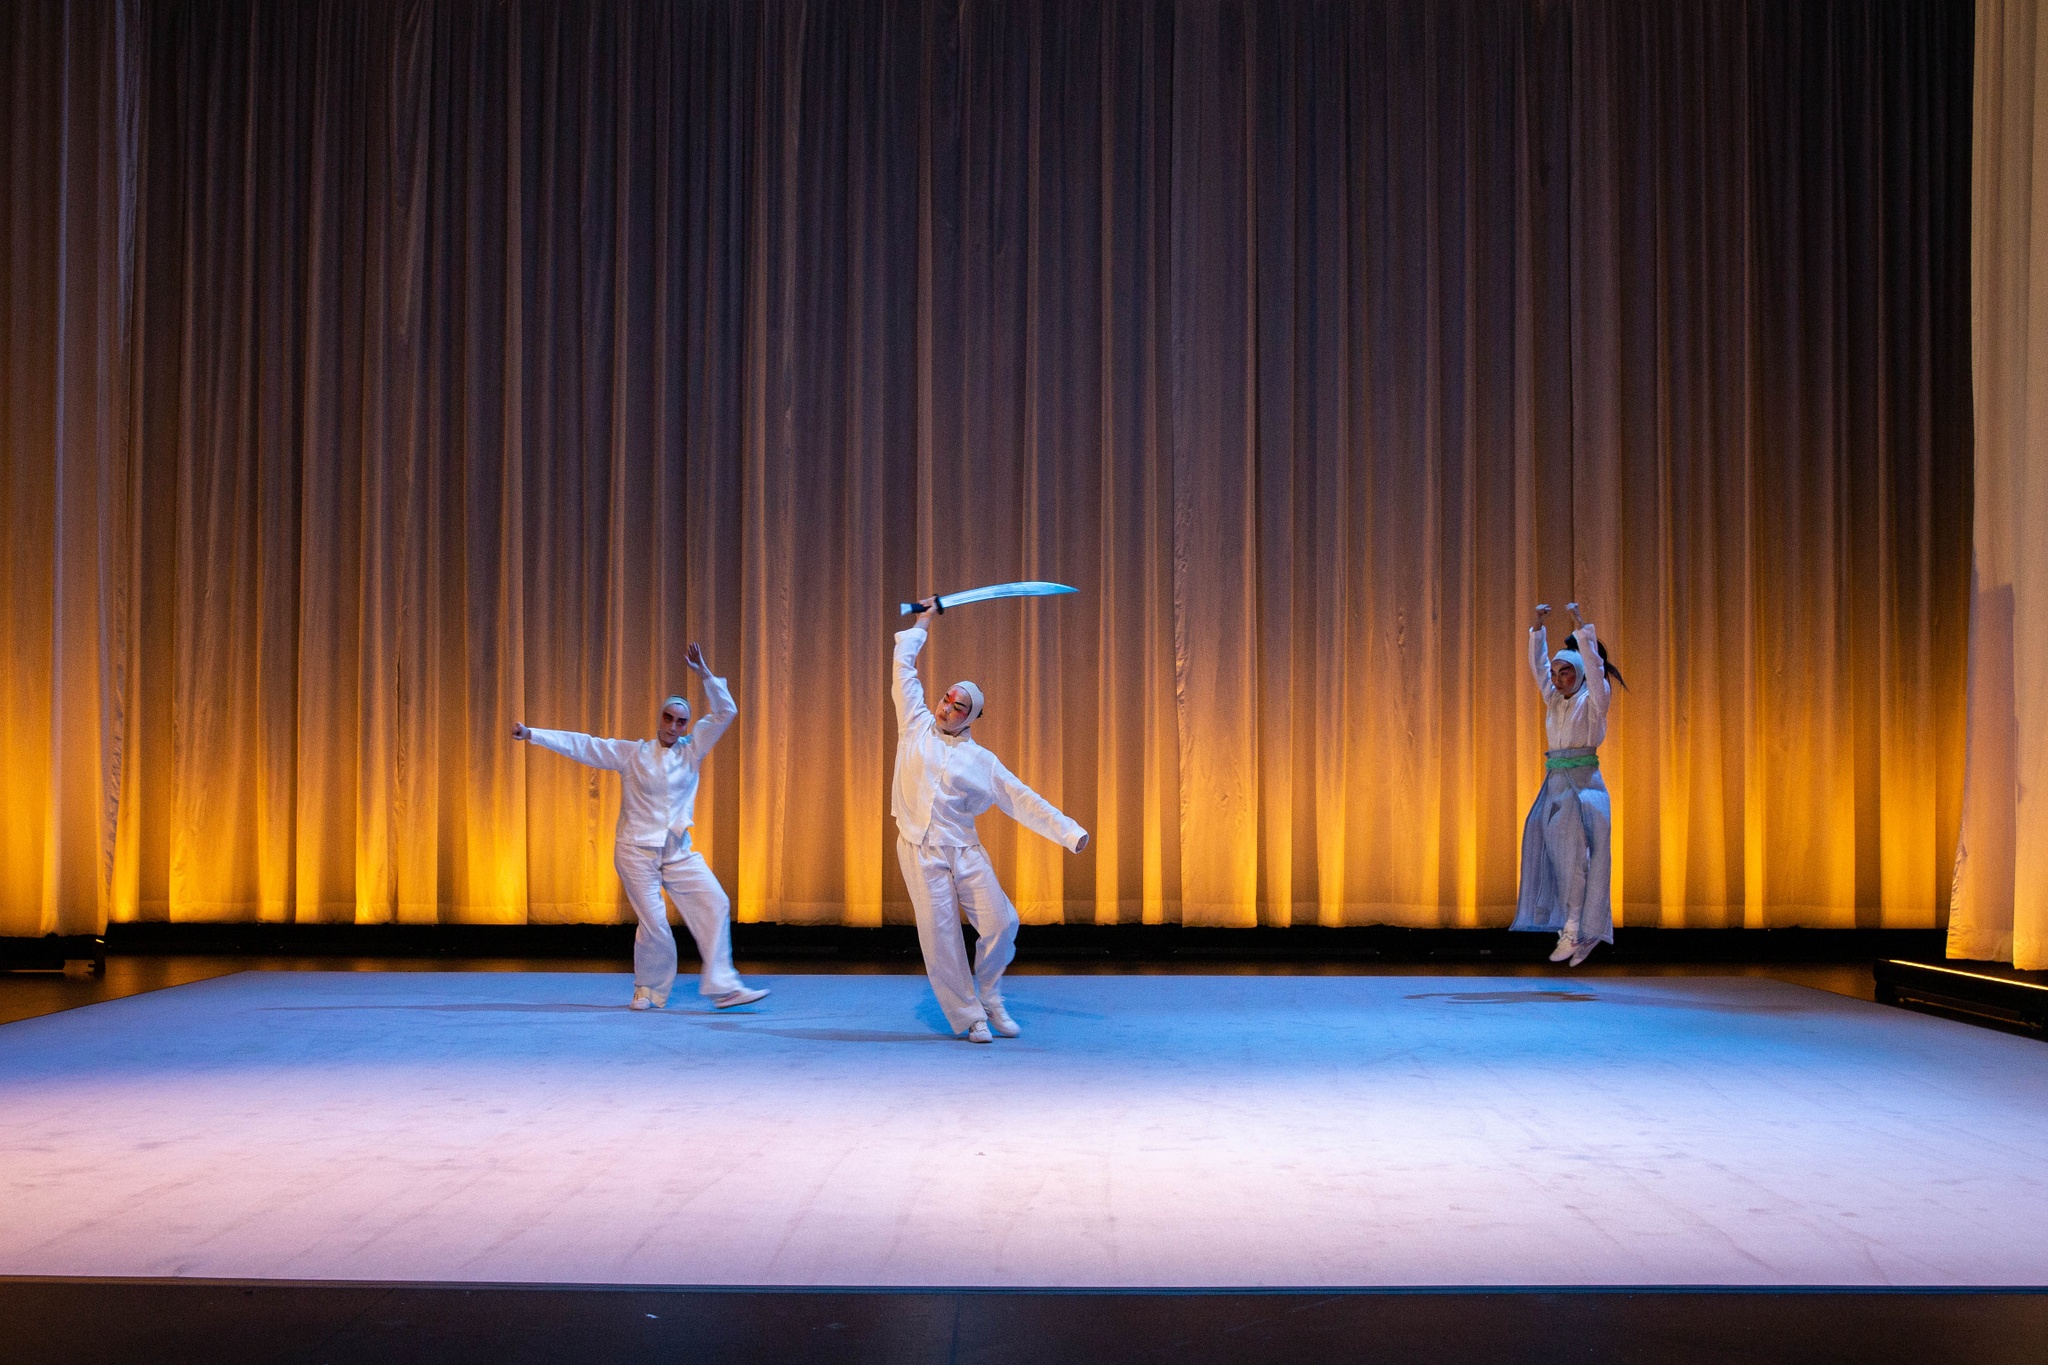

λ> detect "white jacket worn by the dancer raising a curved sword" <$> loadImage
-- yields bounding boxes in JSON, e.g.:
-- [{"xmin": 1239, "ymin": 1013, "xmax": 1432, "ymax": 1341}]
[{"xmin": 889, "ymin": 626, "xmax": 1083, "ymax": 853}]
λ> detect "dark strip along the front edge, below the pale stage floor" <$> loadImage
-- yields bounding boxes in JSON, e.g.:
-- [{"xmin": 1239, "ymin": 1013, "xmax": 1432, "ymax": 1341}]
[{"xmin": 0, "ymin": 1279, "xmax": 2048, "ymax": 1365}]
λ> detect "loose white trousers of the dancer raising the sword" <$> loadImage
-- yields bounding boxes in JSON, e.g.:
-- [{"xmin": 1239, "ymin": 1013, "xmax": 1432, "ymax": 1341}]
[{"xmin": 897, "ymin": 835, "xmax": 1018, "ymax": 1033}]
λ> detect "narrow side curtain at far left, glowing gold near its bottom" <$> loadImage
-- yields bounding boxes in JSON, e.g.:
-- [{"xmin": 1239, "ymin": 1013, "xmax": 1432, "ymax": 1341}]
[{"xmin": 0, "ymin": 0, "xmax": 147, "ymax": 935}]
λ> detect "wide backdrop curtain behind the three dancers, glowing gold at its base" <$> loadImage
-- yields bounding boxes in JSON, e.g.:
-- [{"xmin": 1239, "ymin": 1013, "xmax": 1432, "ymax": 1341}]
[{"xmin": 0, "ymin": 0, "xmax": 1970, "ymax": 931}]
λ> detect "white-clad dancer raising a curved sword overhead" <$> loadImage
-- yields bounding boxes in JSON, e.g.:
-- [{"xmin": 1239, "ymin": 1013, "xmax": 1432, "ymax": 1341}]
[{"xmin": 891, "ymin": 600, "xmax": 1087, "ymax": 1044}]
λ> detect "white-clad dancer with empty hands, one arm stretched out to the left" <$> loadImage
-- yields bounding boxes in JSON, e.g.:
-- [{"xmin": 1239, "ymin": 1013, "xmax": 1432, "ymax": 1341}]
[{"xmin": 512, "ymin": 645, "xmax": 768, "ymax": 1009}]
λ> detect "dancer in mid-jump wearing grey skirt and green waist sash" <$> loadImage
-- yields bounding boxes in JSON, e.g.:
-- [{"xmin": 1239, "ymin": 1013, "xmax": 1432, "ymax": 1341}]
[{"xmin": 1511, "ymin": 602, "xmax": 1628, "ymax": 966}]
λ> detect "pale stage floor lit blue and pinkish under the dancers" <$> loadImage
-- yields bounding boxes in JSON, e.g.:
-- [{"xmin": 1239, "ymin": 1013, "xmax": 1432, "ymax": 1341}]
[{"xmin": 0, "ymin": 972, "xmax": 2048, "ymax": 1287}]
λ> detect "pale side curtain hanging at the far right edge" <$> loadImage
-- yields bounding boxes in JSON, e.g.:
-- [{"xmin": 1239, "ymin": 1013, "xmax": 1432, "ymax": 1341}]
[{"xmin": 1948, "ymin": 0, "xmax": 2048, "ymax": 970}]
